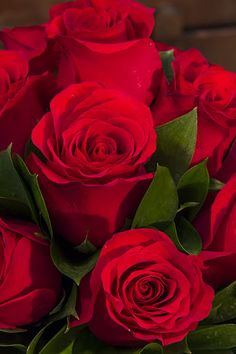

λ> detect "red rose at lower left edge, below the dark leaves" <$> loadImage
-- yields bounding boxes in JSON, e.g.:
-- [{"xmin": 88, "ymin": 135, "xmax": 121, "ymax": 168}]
[{"xmin": 0, "ymin": 219, "xmax": 61, "ymax": 329}]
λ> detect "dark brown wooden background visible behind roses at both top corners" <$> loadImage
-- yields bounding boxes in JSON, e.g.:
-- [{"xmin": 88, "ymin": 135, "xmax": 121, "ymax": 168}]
[{"xmin": 0, "ymin": 0, "xmax": 236, "ymax": 71}]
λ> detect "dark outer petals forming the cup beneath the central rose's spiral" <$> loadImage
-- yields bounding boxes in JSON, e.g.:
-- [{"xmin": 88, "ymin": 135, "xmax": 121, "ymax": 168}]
[{"xmin": 28, "ymin": 155, "xmax": 152, "ymax": 246}]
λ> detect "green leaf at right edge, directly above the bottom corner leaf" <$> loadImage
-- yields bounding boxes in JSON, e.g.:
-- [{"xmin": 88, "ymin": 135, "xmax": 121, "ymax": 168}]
[{"xmin": 204, "ymin": 282, "xmax": 236, "ymax": 323}]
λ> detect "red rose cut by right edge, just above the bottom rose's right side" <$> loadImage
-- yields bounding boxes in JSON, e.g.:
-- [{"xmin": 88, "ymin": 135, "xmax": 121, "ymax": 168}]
[{"xmin": 195, "ymin": 175, "xmax": 236, "ymax": 287}]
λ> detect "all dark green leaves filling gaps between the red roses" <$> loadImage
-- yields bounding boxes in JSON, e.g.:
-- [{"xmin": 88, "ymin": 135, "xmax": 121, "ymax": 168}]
[{"xmin": 0, "ymin": 51, "xmax": 236, "ymax": 354}]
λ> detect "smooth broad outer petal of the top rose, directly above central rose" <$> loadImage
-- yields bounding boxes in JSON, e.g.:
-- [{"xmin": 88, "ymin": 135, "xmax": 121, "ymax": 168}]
[{"xmin": 58, "ymin": 38, "xmax": 162, "ymax": 104}]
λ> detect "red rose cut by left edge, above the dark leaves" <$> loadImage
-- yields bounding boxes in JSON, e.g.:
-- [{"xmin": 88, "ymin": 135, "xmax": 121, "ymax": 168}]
[{"xmin": 0, "ymin": 50, "xmax": 54, "ymax": 155}]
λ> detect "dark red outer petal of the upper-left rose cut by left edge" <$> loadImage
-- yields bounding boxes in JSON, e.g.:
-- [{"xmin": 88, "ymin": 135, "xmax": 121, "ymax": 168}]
[{"xmin": 0, "ymin": 74, "xmax": 55, "ymax": 156}]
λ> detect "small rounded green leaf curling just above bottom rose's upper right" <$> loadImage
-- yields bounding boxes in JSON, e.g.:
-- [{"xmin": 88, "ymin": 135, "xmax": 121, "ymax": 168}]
[{"xmin": 176, "ymin": 217, "xmax": 202, "ymax": 255}]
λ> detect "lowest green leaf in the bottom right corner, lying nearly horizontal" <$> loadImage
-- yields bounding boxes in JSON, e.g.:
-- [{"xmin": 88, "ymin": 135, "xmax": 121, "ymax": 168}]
[{"xmin": 188, "ymin": 324, "xmax": 236, "ymax": 353}]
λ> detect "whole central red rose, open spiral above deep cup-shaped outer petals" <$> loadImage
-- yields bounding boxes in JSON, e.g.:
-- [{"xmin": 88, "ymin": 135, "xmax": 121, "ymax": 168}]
[{"xmin": 28, "ymin": 83, "xmax": 156, "ymax": 246}]
